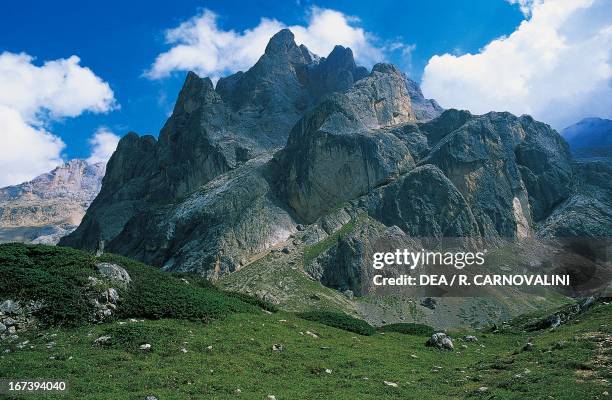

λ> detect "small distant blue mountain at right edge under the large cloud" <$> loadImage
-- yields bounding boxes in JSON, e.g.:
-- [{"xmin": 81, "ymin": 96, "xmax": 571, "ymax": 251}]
[{"xmin": 561, "ymin": 118, "xmax": 612, "ymax": 157}]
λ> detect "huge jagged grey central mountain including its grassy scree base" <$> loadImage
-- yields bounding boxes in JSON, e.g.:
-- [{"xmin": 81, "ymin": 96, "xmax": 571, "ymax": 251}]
[{"xmin": 60, "ymin": 30, "xmax": 612, "ymax": 326}]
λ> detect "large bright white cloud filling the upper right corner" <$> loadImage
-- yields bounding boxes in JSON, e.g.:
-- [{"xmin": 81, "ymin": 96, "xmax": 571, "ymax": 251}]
[{"xmin": 422, "ymin": 0, "xmax": 612, "ymax": 128}]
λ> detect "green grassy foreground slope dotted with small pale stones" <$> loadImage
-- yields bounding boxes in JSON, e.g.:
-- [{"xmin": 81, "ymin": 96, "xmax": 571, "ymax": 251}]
[{"xmin": 0, "ymin": 246, "xmax": 612, "ymax": 400}]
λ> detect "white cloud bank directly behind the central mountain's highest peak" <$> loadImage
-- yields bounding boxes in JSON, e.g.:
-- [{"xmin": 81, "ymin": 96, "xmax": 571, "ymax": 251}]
[{"xmin": 145, "ymin": 7, "xmax": 401, "ymax": 79}]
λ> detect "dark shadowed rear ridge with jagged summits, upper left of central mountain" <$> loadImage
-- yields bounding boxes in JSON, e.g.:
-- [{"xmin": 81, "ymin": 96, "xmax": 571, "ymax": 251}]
[{"xmin": 61, "ymin": 30, "xmax": 440, "ymax": 253}]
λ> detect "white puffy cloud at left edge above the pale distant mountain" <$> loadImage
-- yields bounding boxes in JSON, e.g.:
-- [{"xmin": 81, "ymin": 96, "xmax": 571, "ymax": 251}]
[{"xmin": 0, "ymin": 52, "xmax": 117, "ymax": 186}]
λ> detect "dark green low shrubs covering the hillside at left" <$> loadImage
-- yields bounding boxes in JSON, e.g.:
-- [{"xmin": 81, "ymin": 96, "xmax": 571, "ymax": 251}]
[{"xmin": 0, "ymin": 243, "xmax": 262, "ymax": 326}]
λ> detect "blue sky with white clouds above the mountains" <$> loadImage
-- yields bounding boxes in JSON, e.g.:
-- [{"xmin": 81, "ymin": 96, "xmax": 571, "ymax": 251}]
[{"xmin": 0, "ymin": 0, "xmax": 612, "ymax": 186}]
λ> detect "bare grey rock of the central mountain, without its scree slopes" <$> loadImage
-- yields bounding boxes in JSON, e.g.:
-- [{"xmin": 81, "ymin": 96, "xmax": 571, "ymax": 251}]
[{"xmin": 62, "ymin": 30, "xmax": 596, "ymax": 282}]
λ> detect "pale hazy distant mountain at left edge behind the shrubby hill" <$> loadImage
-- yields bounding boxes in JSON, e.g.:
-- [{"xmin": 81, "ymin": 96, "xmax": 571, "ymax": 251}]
[{"xmin": 0, "ymin": 159, "xmax": 105, "ymax": 244}]
